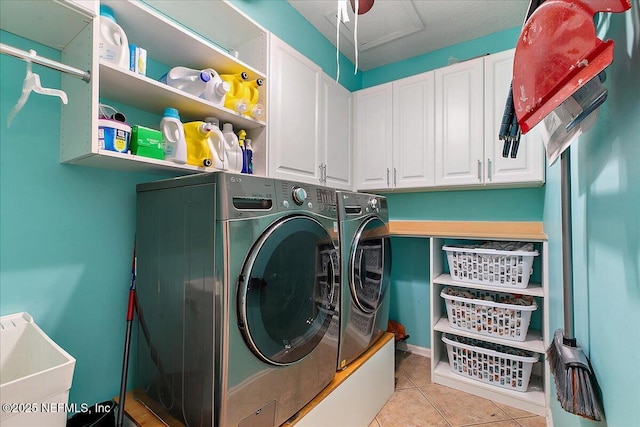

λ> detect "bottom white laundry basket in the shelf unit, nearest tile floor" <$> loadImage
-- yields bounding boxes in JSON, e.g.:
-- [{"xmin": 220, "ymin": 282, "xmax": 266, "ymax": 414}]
[{"xmin": 442, "ymin": 334, "xmax": 538, "ymax": 392}]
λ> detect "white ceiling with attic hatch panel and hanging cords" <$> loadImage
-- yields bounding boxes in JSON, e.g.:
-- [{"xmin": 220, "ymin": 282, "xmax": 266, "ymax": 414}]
[{"xmin": 289, "ymin": 0, "xmax": 529, "ymax": 71}]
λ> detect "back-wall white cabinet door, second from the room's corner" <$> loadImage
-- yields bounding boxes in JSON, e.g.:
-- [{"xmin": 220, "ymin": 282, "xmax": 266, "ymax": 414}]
[{"xmin": 392, "ymin": 71, "xmax": 435, "ymax": 188}]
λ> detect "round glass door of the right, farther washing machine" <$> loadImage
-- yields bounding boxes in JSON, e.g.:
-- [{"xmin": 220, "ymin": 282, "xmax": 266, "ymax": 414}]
[{"xmin": 349, "ymin": 217, "xmax": 391, "ymax": 313}]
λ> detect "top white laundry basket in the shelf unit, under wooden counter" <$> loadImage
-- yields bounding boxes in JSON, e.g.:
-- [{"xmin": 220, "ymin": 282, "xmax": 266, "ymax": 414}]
[{"xmin": 442, "ymin": 242, "xmax": 538, "ymax": 289}]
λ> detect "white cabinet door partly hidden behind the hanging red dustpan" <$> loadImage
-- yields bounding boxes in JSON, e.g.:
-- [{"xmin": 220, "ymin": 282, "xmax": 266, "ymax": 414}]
[{"xmin": 484, "ymin": 49, "xmax": 544, "ymax": 184}]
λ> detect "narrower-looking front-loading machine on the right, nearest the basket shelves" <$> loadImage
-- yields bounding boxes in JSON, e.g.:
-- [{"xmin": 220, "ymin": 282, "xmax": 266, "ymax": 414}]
[{"xmin": 336, "ymin": 191, "xmax": 391, "ymax": 370}]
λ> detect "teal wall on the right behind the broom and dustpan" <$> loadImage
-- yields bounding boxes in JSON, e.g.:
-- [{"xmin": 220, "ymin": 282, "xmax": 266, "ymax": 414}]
[{"xmin": 544, "ymin": 7, "xmax": 640, "ymax": 427}]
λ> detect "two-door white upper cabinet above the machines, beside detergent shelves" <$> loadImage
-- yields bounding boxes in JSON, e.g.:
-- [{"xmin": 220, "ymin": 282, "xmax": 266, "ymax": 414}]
[{"xmin": 268, "ymin": 34, "xmax": 353, "ymax": 189}]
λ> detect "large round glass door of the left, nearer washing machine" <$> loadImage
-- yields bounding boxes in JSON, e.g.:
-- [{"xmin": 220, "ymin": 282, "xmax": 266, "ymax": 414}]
[{"xmin": 238, "ymin": 215, "xmax": 340, "ymax": 365}]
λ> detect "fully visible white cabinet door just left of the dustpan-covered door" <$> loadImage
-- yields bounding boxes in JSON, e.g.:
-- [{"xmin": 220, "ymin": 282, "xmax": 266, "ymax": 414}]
[{"xmin": 435, "ymin": 58, "xmax": 484, "ymax": 186}]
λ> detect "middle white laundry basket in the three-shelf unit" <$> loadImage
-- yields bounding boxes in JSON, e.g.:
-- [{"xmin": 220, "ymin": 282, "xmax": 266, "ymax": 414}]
[{"xmin": 440, "ymin": 287, "xmax": 538, "ymax": 341}]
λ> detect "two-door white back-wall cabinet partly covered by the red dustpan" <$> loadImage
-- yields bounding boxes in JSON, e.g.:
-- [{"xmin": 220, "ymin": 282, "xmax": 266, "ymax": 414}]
[{"xmin": 435, "ymin": 49, "xmax": 544, "ymax": 186}]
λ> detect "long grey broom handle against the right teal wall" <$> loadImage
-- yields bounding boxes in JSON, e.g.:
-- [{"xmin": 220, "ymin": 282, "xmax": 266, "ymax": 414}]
[{"xmin": 560, "ymin": 147, "xmax": 575, "ymax": 339}]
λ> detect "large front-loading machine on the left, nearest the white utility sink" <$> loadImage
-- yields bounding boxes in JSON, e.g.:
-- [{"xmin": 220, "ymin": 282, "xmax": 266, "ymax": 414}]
[{"xmin": 136, "ymin": 173, "xmax": 340, "ymax": 427}]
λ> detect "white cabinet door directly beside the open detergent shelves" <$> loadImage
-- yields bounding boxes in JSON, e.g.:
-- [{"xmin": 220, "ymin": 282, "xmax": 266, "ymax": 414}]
[{"xmin": 268, "ymin": 34, "xmax": 322, "ymax": 183}]
